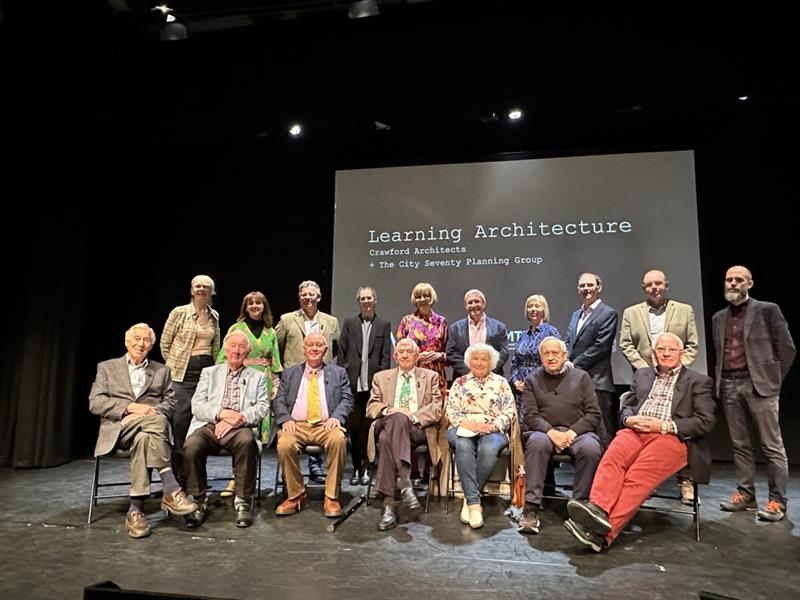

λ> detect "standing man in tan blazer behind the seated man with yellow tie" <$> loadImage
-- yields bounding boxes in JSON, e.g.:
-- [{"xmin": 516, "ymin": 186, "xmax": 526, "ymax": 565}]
[{"xmin": 275, "ymin": 279, "xmax": 339, "ymax": 483}]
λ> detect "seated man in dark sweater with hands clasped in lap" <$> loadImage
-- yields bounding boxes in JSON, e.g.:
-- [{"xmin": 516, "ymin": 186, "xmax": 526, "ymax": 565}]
[{"xmin": 518, "ymin": 336, "xmax": 603, "ymax": 533}]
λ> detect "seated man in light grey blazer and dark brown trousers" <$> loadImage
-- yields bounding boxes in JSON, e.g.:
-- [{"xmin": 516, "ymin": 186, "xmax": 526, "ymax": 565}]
[{"xmin": 183, "ymin": 329, "xmax": 269, "ymax": 527}]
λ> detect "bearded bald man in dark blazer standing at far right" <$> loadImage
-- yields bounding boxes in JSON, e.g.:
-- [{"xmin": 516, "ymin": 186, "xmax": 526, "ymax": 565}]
[{"xmin": 711, "ymin": 266, "xmax": 795, "ymax": 521}]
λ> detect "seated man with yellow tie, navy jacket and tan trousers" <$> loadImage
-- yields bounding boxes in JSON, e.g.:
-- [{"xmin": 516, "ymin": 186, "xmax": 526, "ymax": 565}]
[{"xmin": 274, "ymin": 332, "xmax": 353, "ymax": 517}]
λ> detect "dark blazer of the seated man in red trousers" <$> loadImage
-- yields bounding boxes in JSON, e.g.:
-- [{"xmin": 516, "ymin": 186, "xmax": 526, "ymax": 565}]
[{"xmin": 619, "ymin": 367, "xmax": 717, "ymax": 483}]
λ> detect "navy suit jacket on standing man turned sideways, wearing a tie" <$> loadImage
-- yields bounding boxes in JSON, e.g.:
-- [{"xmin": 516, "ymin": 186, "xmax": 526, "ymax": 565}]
[{"xmin": 565, "ymin": 302, "xmax": 619, "ymax": 392}]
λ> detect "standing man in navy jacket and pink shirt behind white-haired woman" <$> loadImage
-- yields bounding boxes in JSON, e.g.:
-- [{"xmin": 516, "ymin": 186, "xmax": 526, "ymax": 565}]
[{"xmin": 445, "ymin": 289, "xmax": 508, "ymax": 379}]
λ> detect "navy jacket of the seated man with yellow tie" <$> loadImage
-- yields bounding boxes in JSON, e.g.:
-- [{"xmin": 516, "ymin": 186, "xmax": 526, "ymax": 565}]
[{"xmin": 272, "ymin": 363, "xmax": 353, "ymax": 425}]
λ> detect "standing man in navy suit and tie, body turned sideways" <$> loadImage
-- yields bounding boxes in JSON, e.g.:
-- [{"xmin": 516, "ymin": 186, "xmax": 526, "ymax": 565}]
[{"xmin": 566, "ymin": 273, "xmax": 619, "ymax": 447}]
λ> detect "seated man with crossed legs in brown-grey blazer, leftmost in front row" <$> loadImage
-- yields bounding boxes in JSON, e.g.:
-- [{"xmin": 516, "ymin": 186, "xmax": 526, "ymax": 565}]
[{"xmin": 89, "ymin": 323, "xmax": 197, "ymax": 538}]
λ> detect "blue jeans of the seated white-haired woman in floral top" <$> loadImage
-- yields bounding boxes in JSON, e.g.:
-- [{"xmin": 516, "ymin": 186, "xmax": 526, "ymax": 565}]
[{"xmin": 447, "ymin": 427, "xmax": 508, "ymax": 504}]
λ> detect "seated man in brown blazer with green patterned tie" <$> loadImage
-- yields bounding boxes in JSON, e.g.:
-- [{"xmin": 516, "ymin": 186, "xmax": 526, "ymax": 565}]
[{"xmin": 367, "ymin": 338, "xmax": 442, "ymax": 531}]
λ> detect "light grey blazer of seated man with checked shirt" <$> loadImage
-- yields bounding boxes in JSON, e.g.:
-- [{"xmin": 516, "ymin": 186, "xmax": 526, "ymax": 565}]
[{"xmin": 186, "ymin": 363, "xmax": 269, "ymax": 439}]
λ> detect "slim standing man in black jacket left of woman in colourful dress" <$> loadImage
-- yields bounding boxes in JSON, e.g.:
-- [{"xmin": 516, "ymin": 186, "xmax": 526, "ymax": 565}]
[{"xmin": 339, "ymin": 285, "xmax": 392, "ymax": 485}]
